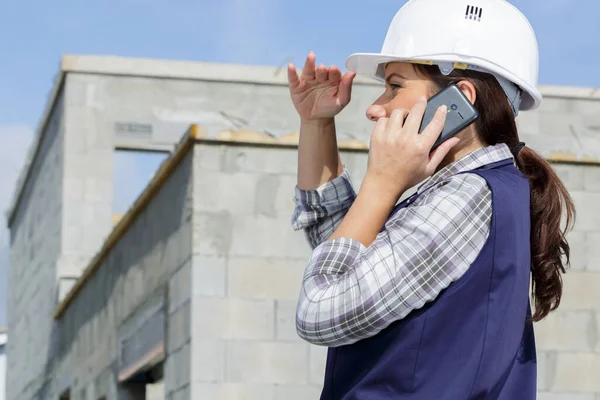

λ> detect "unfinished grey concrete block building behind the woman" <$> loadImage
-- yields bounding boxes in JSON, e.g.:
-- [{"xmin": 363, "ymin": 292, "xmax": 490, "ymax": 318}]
[{"xmin": 7, "ymin": 56, "xmax": 600, "ymax": 400}]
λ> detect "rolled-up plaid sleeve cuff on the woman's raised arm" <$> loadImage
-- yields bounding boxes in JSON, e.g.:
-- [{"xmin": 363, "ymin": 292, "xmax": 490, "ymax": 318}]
[{"xmin": 291, "ymin": 168, "xmax": 356, "ymax": 249}]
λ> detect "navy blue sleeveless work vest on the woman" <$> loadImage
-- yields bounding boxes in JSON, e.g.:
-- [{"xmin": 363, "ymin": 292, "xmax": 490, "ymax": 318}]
[{"xmin": 321, "ymin": 160, "xmax": 536, "ymax": 400}]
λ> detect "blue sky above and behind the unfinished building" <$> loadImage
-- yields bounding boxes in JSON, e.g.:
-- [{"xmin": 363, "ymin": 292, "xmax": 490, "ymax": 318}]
[{"xmin": 0, "ymin": 0, "xmax": 600, "ymax": 326}]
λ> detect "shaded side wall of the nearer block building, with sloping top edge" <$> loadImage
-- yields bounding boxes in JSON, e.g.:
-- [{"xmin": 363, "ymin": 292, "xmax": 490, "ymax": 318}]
[{"xmin": 49, "ymin": 154, "xmax": 193, "ymax": 400}]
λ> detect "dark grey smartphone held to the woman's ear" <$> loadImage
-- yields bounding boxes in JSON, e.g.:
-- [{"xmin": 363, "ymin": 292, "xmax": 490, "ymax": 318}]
[{"xmin": 419, "ymin": 84, "xmax": 479, "ymax": 151}]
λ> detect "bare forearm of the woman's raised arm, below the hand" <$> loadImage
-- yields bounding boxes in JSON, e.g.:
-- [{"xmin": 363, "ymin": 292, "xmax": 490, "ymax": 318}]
[{"xmin": 298, "ymin": 118, "xmax": 343, "ymax": 190}]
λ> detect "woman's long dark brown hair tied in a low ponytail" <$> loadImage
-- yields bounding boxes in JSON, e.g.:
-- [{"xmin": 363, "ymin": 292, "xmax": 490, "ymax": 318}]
[{"xmin": 415, "ymin": 64, "xmax": 575, "ymax": 321}]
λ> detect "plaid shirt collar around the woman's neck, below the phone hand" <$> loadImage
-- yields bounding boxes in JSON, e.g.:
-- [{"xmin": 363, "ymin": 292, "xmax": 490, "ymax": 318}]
[{"xmin": 417, "ymin": 143, "xmax": 514, "ymax": 194}]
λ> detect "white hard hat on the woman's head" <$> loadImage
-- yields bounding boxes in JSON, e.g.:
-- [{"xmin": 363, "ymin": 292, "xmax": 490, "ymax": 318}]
[{"xmin": 346, "ymin": 0, "xmax": 542, "ymax": 114}]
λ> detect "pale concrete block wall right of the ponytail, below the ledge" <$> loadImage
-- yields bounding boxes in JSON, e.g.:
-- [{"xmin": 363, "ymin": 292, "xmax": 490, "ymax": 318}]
[{"xmin": 535, "ymin": 164, "xmax": 600, "ymax": 400}]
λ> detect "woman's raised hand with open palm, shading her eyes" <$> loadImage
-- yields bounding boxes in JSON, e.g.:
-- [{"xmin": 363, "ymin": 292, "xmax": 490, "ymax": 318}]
[{"xmin": 288, "ymin": 52, "xmax": 356, "ymax": 121}]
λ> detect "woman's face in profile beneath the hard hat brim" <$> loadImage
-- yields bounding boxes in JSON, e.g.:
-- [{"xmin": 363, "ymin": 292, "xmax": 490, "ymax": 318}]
[{"xmin": 367, "ymin": 62, "xmax": 432, "ymax": 121}]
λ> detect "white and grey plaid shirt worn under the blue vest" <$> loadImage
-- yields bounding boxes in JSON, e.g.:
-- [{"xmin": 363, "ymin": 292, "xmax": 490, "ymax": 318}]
[{"xmin": 292, "ymin": 144, "xmax": 513, "ymax": 347}]
